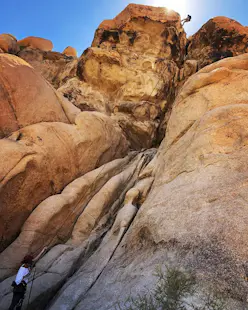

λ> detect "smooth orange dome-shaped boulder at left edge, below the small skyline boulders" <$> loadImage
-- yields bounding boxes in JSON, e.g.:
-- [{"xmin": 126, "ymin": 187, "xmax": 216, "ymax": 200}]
[{"xmin": 0, "ymin": 54, "xmax": 69, "ymax": 138}]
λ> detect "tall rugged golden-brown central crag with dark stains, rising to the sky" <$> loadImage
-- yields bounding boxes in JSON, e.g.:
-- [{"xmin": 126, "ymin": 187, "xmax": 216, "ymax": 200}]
[{"xmin": 59, "ymin": 4, "xmax": 186, "ymax": 149}]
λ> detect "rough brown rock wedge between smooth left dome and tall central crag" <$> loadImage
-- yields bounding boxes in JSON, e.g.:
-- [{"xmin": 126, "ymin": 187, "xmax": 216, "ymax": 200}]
[{"xmin": 18, "ymin": 47, "xmax": 77, "ymax": 88}]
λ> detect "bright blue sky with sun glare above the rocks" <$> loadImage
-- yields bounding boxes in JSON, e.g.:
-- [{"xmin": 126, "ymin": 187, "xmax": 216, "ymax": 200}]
[{"xmin": 0, "ymin": 0, "xmax": 248, "ymax": 55}]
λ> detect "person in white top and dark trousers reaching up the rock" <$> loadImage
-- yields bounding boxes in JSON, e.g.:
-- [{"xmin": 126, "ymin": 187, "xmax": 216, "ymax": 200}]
[{"xmin": 9, "ymin": 247, "xmax": 47, "ymax": 310}]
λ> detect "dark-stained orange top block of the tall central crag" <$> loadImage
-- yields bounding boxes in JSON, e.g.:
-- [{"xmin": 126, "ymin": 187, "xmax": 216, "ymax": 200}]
[{"xmin": 92, "ymin": 4, "xmax": 186, "ymax": 63}]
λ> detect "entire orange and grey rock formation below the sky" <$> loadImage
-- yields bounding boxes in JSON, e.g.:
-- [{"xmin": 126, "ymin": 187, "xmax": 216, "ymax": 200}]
[{"xmin": 0, "ymin": 4, "xmax": 248, "ymax": 310}]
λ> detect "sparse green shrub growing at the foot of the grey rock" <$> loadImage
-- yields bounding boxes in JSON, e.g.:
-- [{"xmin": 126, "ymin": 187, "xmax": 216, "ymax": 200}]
[{"xmin": 116, "ymin": 267, "xmax": 225, "ymax": 310}]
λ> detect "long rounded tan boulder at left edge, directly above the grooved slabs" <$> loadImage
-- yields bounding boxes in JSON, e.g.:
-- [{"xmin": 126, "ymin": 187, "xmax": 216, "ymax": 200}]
[{"xmin": 0, "ymin": 112, "xmax": 128, "ymax": 249}]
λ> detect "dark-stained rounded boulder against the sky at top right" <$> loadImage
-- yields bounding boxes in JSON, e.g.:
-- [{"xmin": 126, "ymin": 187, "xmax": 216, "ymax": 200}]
[{"xmin": 187, "ymin": 16, "xmax": 248, "ymax": 68}]
